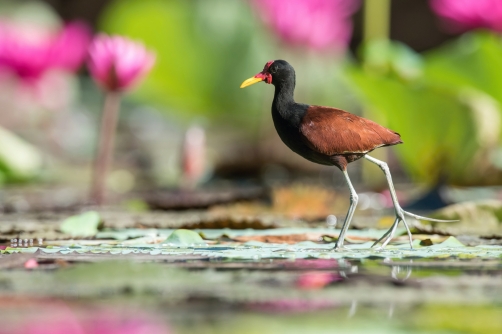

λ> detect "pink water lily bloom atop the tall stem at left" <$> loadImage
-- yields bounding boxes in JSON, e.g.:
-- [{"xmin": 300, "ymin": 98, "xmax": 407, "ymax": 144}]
[{"xmin": 88, "ymin": 34, "xmax": 155, "ymax": 91}]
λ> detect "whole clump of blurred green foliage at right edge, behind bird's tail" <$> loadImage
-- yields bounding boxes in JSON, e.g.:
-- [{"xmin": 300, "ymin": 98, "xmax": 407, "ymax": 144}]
[{"xmin": 347, "ymin": 33, "xmax": 502, "ymax": 185}]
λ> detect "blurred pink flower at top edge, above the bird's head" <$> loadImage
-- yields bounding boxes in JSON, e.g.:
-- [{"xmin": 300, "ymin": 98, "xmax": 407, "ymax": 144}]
[{"xmin": 254, "ymin": 0, "xmax": 360, "ymax": 50}]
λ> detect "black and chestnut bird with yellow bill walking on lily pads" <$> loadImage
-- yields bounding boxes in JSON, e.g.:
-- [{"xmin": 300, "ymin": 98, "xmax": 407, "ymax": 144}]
[{"xmin": 240, "ymin": 59, "xmax": 451, "ymax": 250}]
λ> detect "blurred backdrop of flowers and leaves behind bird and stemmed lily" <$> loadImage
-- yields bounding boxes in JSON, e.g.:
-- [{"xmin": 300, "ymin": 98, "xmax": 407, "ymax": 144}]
[{"xmin": 0, "ymin": 0, "xmax": 502, "ymax": 211}]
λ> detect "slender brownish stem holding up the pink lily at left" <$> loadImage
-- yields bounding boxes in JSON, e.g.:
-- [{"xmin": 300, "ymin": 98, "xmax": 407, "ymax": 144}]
[{"xmin": 91, "ymin": 92, "xmax": 120, "ymax": 205}]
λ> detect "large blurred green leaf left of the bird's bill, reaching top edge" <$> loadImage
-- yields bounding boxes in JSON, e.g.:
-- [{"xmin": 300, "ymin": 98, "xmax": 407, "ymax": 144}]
[{"xmin": 101, "ymin": 0, "xmax": 266, "ymax": 125}]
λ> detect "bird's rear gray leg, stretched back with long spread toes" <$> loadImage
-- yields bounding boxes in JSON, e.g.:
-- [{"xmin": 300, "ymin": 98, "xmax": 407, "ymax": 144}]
[{"xmin": 364, "ymin": 155, "xmax": 456, "ymax": 248}]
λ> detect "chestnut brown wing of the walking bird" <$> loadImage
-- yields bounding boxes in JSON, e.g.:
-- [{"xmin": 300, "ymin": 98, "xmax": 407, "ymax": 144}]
[{"xmin": 300, "ymin": 106, "xmax": 402, "ymax": 156}]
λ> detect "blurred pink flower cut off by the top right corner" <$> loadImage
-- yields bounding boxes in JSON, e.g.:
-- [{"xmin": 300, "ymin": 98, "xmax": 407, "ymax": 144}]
[{"xmin": 430, "ymin": 0, "xmax": 502, "ymax": 32}]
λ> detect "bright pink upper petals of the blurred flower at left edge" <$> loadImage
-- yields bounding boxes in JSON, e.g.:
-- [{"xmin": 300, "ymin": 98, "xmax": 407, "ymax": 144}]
[{"xmin": 0, "ymin": 22, "xmax": 90, "ymax": 81}]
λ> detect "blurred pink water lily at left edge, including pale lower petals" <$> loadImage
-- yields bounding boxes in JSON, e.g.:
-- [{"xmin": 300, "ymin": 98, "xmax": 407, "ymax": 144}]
[{"xmin": 0, "ymin": 16, "xmax": 91, "ymax": 129}]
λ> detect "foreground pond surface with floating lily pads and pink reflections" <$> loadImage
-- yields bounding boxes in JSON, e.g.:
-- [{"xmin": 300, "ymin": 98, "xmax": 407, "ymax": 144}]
[{"xmin": 0, "ymin": 229, "xmax": 502, "ymax": 334}]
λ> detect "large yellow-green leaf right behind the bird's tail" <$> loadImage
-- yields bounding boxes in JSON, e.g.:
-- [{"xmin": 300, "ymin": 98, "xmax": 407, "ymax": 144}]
[{"xmin": 347, "ymin": 47, "xmax": 482, "ymax": 183}]
